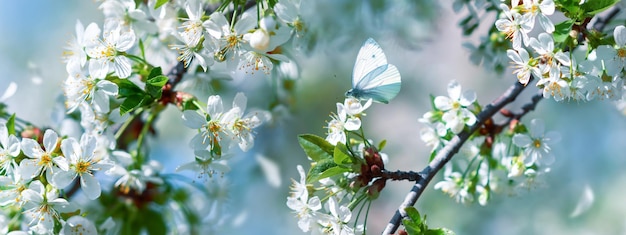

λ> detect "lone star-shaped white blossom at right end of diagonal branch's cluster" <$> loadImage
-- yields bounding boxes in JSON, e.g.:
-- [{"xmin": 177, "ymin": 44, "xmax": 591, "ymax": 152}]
[{"xmin": 513, "ymin": 119, "xmax": 561, "ymax": 165}]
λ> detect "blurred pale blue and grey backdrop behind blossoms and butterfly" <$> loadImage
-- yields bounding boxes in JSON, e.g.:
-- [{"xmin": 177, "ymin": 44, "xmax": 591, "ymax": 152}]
[{"xmin": 0, "ymin": 0, "xmax": 626, "ymax": 234}]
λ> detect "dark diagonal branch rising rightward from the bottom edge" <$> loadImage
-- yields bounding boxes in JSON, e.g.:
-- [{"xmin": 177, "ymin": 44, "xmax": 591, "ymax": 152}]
[{"xmin": 382, "ymin": 77, "xmax": 541, "ymax": 234}]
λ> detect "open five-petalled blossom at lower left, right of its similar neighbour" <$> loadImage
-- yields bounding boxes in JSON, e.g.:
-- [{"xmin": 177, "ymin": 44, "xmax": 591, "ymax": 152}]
[{"xmin": 53, "ymin": 134, "xmax": 113, "ymax": 200}]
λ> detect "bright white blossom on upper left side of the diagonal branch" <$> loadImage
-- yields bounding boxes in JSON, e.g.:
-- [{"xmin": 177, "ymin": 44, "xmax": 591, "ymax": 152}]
[{"xmin": 434, "ymin": 80, "xmax": 476, "ymax": 134}]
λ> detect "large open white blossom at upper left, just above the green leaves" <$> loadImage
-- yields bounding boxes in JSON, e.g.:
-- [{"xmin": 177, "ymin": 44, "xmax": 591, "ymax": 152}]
[{"xmin": 85, "ymin": 21, "xmax": 136, "ymax": 78}]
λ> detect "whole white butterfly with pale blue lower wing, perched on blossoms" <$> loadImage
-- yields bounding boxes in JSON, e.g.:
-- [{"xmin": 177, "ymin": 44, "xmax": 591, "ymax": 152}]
[{"xmin": 346, "ymin": 38, "xmax": 401, "ymax": 104}]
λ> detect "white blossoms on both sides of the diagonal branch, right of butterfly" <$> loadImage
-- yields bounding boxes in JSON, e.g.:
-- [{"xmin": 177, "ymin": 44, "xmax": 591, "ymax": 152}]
[{"xmin": 419, "ymin": 81, "xmax": 560, "ymax": 205}]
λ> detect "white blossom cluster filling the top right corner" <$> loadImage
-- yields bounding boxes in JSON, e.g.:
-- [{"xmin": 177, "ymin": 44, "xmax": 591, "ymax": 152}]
[{"xmin": 495, "ymin": 0, "xmax": 626, "ymax": 101}]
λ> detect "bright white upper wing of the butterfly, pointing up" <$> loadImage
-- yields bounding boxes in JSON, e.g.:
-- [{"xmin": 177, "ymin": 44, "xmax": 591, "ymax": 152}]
[{"xmin": 352, "ymin": 38, "xmax": 387, "ymax": 88}]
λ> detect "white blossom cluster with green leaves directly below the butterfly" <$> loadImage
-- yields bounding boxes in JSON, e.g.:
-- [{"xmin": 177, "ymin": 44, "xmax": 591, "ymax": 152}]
[{"xmin": 287, "ymin": 97, "xmax": 387, "ymax": 234}]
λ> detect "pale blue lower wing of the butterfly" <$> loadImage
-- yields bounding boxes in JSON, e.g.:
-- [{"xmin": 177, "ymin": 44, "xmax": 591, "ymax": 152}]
[{"xmin": 348, "ymin": 64, "xmax": 401, "ymax": 104}]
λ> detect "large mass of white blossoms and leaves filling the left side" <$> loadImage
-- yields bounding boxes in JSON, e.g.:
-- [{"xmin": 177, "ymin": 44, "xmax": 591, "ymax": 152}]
[{"xmin": 0, "ymin": 0, "xmax": 306, "ymax": 234}]
